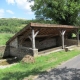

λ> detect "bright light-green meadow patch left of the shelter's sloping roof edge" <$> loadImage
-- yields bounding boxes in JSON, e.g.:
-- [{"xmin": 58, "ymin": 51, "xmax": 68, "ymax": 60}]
[{"xmin": 0, "ymin": 33, "xmax": 14, "ymax": 46}]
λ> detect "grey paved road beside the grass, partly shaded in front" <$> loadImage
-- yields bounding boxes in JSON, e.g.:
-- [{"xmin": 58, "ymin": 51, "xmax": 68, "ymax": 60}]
[{"xmin": 35, "ymin": 55, "xmax": 80, "ymax": 80}]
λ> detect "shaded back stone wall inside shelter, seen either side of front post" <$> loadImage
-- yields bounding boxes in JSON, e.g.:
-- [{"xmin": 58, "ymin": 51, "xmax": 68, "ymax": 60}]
[{"xmin": 22, "ymin": 38, "xmax": 61, "ymax": 50}]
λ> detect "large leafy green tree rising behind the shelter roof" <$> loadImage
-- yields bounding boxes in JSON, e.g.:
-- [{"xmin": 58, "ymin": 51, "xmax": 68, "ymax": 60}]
[{"xmin": 28, "ymin": 0, "xmax": 80, "ymax": 25}]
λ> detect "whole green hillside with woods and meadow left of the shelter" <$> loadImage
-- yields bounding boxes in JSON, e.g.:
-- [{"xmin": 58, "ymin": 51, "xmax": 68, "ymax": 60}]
[{"xmin": 0, "ymin": 18, "xmax": 32, "ymax": 45}]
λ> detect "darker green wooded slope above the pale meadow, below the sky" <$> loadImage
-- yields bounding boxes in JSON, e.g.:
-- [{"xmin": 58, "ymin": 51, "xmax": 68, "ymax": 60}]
[{"xmin": 0, "ymin": 18, "xmax": 30, "ymax": 33}]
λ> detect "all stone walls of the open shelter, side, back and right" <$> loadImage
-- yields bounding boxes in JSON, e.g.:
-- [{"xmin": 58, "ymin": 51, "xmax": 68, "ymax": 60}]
[{"xmin": 8, "ymin": 37, "xmax": 77, "ymax": 58}]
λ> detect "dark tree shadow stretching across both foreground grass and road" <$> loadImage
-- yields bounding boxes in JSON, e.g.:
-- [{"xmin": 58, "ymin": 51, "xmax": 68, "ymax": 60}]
[{"xmin": 1, "ymin": 67, "xmax": 80, "ymax": 80}]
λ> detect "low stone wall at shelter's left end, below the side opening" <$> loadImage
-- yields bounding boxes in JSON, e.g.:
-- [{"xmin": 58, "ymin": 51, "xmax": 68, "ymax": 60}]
[{"xmin": 10, "ymin": 47, "xmax": 36, "ymax": 59}]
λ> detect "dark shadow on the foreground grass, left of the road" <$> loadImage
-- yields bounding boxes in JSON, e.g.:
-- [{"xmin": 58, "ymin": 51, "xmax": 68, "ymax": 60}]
[{"xmin": 1, "ymin": 68, "xmax": 47, "ymax": 80}]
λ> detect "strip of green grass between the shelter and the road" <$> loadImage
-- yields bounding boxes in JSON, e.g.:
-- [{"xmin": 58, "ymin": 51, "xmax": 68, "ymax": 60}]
[{"xmin": 0, "ymin": 50, "xmax": 80, "ymax": 80}]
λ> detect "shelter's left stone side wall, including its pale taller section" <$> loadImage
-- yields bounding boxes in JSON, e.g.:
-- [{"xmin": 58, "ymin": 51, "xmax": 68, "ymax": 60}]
[{"xmin": 6, "ymin": 38, "xmax": 37, "ymax": 59}]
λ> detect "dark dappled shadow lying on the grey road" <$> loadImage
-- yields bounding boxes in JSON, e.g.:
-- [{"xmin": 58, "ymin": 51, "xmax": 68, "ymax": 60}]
[{"xmin": 35, "ymin": 67, "xmax": 80, "ymax": 80}]
